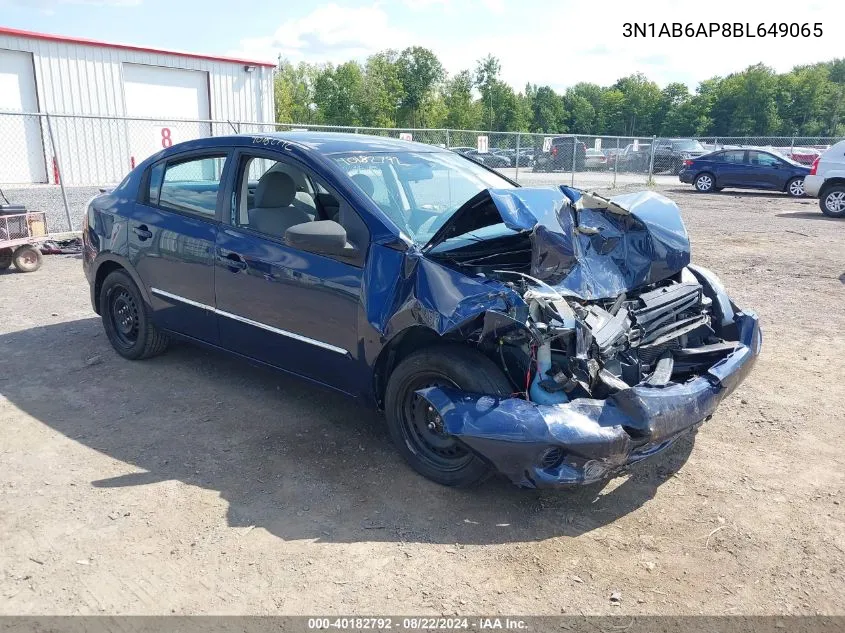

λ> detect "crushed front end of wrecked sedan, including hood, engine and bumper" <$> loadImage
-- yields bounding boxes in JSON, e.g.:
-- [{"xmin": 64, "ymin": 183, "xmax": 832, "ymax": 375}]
[{"xmin": 418, "ymin": 185, "xmax": 762, "ymax": 487}]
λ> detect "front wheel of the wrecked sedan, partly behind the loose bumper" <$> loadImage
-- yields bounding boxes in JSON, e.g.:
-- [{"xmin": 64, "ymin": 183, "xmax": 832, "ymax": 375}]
[{"xmin": 385, "ymin": 344, "xmax": 512, "ymax": 486}]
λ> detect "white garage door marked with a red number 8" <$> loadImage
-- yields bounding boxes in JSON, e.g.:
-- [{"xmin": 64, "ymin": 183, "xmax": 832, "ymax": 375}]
[{"xmin": 123, "ymin": 63, "xmax": 211, "ymax": 164}]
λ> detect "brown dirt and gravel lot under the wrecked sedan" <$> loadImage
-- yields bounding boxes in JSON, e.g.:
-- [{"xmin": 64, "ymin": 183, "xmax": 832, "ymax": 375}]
[{"xmin": 0, "ymin": 186, "xmax": 845, "ymax": 614}]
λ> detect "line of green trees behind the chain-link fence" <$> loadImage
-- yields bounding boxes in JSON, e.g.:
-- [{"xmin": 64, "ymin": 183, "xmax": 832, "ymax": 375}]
[{"xmin": 274, "ymin": 46, "xmax": 845, "ymax": 136}]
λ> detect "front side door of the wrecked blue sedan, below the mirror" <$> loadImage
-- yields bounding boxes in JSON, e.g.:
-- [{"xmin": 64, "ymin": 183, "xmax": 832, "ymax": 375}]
[{"xmin": 214, "ymin": 151, "xmax": 369, "ymax": 393}]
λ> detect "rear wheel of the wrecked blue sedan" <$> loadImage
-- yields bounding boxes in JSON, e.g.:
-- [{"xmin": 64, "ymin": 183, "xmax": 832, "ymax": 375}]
[{"xmin": 100, "ymin": 270, "xmax": 168, "ymax": 360}]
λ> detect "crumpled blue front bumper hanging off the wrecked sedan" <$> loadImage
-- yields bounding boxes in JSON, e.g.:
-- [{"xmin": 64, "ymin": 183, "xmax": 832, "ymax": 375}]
[{"xmin": 418, "ymin": 313, "xmax": 762, "ymax": 488}]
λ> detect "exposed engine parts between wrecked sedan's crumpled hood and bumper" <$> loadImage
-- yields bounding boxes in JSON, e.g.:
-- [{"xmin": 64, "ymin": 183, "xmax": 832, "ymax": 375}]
[{"xmin": 485, "ymin": 269, "xmax": 737, "ymax": 404}]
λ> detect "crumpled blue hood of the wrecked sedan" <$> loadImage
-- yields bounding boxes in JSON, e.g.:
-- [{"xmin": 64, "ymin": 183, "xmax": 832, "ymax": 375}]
[{"xmin": 424, "ymin": 187, "xmax": 690, "ymax": 300}]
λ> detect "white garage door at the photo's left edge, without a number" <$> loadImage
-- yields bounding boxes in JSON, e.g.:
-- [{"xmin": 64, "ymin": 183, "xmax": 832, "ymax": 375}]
[{"xmin": 0, "ymin": 49, "xmax": 47, "ymax": 184}]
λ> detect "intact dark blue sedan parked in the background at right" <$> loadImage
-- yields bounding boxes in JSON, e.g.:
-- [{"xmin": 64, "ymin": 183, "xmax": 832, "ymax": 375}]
[{"xmin": 678, "ymin": 149, "xmax": 810, "ymax": 198}]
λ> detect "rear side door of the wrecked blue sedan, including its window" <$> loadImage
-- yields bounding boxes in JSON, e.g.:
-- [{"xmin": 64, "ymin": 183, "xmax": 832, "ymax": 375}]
[{"xmin": 128, "ymin": 152, "xmax": 228, "ymax": 344}]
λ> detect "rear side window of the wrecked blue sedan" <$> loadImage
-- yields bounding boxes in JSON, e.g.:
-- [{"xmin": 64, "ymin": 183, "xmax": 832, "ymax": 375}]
[{"xmin": 148, "ymin": 156, "xmax": 226, "ymax": 218}]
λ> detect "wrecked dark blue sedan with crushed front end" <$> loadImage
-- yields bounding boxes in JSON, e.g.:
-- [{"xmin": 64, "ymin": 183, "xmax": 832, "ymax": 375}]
[{"xmin": 83, "ymin": 132, "xmax": 761, "ymax": 487}]
